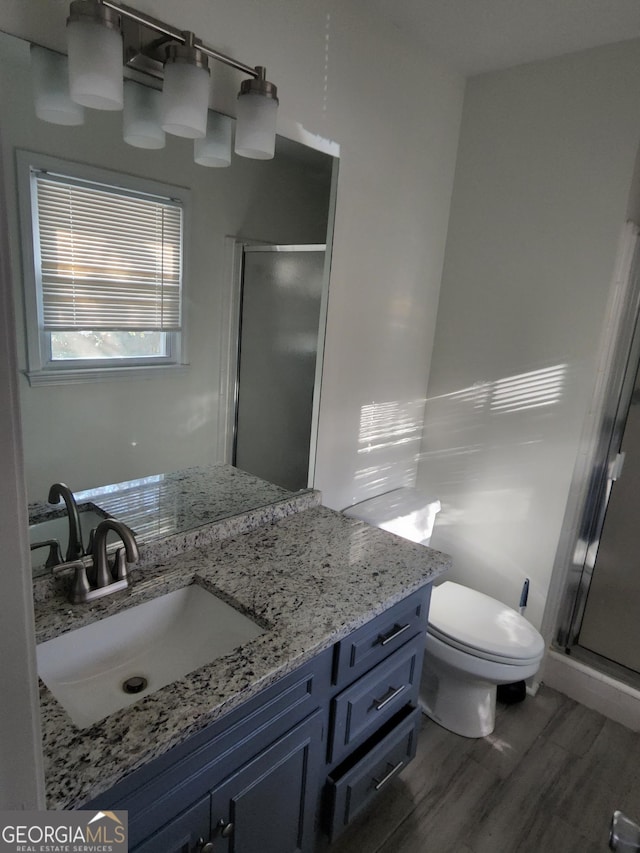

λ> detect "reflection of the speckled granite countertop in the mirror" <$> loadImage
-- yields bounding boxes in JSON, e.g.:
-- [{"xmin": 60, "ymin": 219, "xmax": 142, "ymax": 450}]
[{"xmin": 29, "ymin": 464, "xmax": 320, "ymax": 576}]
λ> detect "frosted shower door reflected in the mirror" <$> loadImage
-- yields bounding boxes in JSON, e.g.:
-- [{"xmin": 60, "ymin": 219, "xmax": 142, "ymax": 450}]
[{"xmin": 234, "ymin": 245, "xmax": 325, "ymax": 491}]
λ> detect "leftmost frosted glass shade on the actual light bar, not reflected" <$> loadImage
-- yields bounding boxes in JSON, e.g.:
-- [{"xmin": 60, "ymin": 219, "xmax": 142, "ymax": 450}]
[{"xmin": 67, "ymin": 19, "xmax": 123, "ymax": 110}]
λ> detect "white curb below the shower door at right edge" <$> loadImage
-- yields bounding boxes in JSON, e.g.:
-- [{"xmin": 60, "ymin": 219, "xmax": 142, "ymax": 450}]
[{"xmin": 541, "ymin": 650, "xmax": 640, "ymax": 732}]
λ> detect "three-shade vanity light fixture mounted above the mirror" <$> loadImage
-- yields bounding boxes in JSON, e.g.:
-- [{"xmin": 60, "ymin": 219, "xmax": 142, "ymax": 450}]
[{"xmin": 59, "ymin": 0, "xmax": 278, "ymax": 161}]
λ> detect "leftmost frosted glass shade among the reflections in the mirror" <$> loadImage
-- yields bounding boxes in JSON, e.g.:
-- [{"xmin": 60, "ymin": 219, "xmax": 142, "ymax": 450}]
[{"xmin": 31, "ymin": 44, "xmax": 84, "ymax": 125}]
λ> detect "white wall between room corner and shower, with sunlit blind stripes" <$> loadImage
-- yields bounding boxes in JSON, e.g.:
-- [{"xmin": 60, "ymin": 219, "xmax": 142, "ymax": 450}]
[{"xmin": 419, "ymin": 41, "xmax": 640, "ymax": 626}]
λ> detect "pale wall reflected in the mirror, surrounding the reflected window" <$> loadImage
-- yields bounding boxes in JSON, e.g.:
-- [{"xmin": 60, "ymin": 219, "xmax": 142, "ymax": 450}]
[{"xmin": 0, "ymin": 33, "xmax": 334, "ymax": 524}]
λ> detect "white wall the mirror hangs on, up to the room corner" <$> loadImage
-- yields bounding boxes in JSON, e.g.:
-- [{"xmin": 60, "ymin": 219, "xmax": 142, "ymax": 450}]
[{"xmin": 0, "ymin": 0, "xmax": 464, "ymax": 804}]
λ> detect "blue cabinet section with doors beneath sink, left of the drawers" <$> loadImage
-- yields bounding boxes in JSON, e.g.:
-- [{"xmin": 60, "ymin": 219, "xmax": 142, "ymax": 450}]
[{"xmin": 90, "ymin": 649, "xmax": 333, "ymax": 853}]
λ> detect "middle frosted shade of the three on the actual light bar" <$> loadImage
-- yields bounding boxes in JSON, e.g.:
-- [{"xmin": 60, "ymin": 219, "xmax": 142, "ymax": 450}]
[{"xmin": 162, "ymin": 62, "xmax": 209, "ymax": 139}]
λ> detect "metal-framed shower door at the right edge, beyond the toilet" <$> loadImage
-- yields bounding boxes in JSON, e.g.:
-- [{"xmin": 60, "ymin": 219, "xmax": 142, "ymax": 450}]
[{"xmin": 556, "ymin": 223, "xmax": 640, "ymax": 688}]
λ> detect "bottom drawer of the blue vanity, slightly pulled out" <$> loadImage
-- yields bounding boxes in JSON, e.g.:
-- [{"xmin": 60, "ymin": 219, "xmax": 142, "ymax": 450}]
[{"xmin": 327, "ymin": 708, "xmax": 421, "ymax": 841}]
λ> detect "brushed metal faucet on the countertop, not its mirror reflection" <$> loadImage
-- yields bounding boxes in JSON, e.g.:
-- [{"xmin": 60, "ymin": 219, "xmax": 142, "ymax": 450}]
[{"xmin": 53, "ymin": 518, "xmax": 140, "ymax": 604}]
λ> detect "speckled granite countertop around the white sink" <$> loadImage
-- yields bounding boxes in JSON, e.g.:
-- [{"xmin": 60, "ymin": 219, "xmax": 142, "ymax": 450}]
[{"xmin": 36, "ymin": 507, "xmax": 450, "ymax": 809}]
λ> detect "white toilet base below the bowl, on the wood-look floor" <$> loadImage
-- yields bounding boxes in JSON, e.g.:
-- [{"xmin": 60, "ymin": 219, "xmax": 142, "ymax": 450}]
[{"xmin": 420, "ymin": 661, "xmax": 497, "ymax": 738}]
